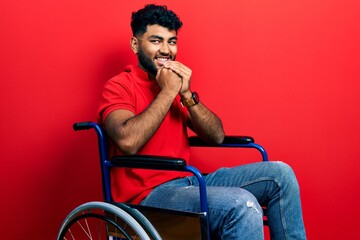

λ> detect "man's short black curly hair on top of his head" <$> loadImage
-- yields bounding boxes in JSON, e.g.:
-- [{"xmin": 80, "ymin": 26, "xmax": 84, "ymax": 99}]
[{"xmin": 131, "ymin": 4, "xmax": 182, "ymax": 36}]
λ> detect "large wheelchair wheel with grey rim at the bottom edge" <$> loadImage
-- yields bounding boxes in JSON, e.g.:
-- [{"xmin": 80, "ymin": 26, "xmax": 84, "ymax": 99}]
[{"xmin": 57, "ymin": 202, "xmax": 161, "ymax": 240}]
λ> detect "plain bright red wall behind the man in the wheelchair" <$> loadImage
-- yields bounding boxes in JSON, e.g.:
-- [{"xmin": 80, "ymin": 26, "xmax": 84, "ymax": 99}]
[{"xmin": 0, "ymin": 0, "xmax": 360, "ymax": 239}]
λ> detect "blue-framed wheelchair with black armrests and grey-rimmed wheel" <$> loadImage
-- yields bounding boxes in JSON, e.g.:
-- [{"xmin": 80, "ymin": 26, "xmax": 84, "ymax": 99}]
[{"xmin": 57, "ymin": 122, "xmax": 268, "ymax": 240}]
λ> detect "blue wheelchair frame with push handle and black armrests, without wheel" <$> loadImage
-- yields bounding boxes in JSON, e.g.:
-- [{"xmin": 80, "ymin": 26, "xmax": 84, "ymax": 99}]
[{"xmin": 73, "ymin": 122, "xmax": 268, "ymax": 238}]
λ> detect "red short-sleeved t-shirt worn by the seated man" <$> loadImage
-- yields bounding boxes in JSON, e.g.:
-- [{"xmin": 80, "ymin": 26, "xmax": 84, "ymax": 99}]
[{"xmin": 98, "ymin": 65, "xmax": 189, "ymax": 203}]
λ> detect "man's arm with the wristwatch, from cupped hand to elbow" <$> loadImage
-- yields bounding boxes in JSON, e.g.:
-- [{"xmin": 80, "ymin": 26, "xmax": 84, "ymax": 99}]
[{"xmin": 164, "ymin": 61, "xmax": 225, "ymax": 144}]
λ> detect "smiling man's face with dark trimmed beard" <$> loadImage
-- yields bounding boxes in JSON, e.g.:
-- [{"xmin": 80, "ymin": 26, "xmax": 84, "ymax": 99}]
[{"xmin": 132, "ymin": 25, "xmax": 177, "ymax": 76}]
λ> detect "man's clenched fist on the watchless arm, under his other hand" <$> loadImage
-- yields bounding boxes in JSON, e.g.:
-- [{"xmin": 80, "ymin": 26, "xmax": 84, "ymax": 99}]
[{"xmin": 156, "ymin": 67, "xmax": 183, "ymax": 96}]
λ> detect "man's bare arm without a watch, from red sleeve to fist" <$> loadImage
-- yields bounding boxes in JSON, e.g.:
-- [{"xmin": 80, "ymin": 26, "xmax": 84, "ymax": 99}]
[{"xmin": 104, "ymin": 69, "xmax": 181, "ymax": 154}]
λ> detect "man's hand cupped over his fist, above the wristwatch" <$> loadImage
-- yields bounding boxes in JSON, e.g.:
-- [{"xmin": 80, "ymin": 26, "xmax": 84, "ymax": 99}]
[{"xmin": 163, "ymin": 61, "xmax": 192, "ymax": 97}]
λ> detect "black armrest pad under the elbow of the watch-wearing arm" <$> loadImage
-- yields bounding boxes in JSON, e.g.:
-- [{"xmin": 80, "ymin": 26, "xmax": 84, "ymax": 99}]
[{"xmin": 189, "ymin": 136, "xmax": 255, "ymax": 147}]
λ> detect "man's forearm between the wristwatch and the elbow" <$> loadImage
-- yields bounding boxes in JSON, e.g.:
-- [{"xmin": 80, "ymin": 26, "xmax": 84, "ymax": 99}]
[{"xmin": 188, "ymin": 102, "xmax": 225, "ymax": 144}]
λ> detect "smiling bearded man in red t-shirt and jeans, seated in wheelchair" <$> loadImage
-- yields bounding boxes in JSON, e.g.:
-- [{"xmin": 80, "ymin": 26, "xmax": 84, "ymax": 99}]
[{"xmin": 99, "ymin": 4, "xmax": 305, "ymax": 239}]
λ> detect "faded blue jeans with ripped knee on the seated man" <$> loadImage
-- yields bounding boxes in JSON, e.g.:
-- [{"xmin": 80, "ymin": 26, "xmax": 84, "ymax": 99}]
[{"xmin": 141, "ymin": 162, "xmax": 306, "ymax": 240}]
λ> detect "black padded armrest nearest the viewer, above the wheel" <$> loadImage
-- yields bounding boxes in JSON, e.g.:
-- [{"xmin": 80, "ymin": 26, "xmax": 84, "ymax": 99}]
[{"xmin": 110, "ymin": 155, "xmax": 186, "ymax": 171}]
